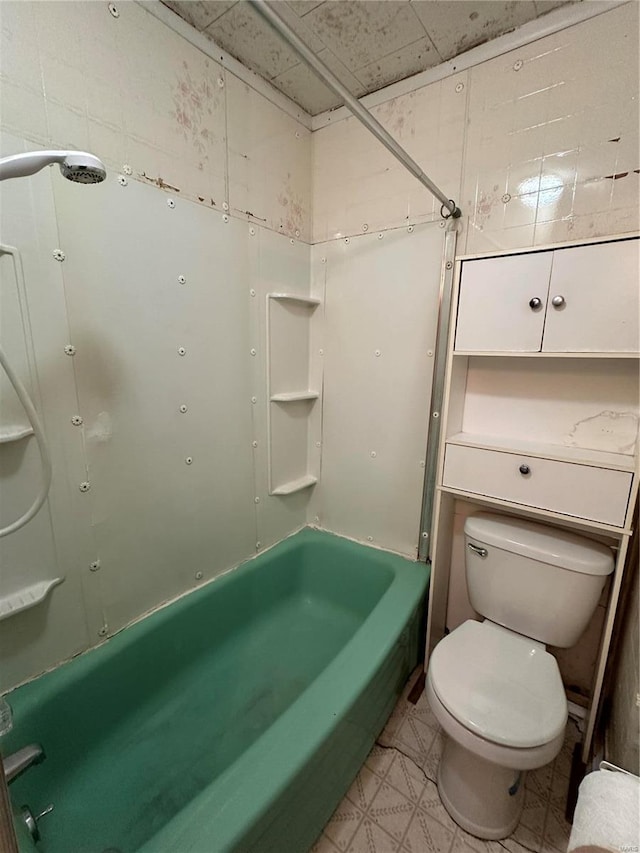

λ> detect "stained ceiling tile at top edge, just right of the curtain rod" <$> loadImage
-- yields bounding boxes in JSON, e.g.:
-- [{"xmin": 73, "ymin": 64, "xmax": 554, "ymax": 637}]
[{"xmin": 304, "ymin": 0, "xmax": 425, "ymax": 71}]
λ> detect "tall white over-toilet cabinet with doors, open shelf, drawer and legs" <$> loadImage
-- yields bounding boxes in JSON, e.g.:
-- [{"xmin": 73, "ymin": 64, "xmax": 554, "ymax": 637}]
[{"xmin": 427, "ymin": 238, "xmax": 640, "ymax": 759}]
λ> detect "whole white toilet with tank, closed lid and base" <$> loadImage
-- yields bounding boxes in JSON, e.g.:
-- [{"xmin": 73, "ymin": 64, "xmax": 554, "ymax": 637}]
[{"xmin": 426, "ymin": 513, "xmax": 614, "ymax": 839}]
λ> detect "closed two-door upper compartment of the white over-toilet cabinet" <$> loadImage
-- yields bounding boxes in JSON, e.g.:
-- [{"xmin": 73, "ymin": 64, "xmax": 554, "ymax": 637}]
[{"xmin": 455, "ymin": 240, "xmax": 640, "ymax": 353}]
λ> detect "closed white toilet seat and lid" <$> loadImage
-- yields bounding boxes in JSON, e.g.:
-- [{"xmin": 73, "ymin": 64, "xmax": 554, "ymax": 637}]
[{"xmin": 429, "ymin": 620, "xmax": 567, "ymax": 748}]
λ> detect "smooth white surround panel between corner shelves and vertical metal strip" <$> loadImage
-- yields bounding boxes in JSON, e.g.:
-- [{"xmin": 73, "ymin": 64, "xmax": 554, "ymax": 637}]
[{"xmin": 313, "ymin": 223, "xmax": 444, "ymax": 556}]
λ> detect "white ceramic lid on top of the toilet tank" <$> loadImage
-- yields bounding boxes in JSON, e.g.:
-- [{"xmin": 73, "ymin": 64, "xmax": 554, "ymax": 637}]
[{"xmin": 464, "ymin": 512, "xmax": 614, "ymax": 575}]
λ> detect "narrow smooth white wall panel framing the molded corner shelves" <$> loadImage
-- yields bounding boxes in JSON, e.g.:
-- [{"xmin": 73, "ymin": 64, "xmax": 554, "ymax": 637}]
[{"xmin": 244, "ymin": 223, "xmax": 321, "ymax": 550}]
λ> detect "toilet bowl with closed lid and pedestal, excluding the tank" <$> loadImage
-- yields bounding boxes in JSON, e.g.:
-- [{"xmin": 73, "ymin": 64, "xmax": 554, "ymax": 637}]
[{"xmin": 426, "ymin": 620, "xmax": 567, "ymax": 840}]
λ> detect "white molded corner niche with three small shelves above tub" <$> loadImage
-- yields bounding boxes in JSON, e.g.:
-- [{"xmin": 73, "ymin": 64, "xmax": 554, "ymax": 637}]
[{"xmin": 267, "ymin": 293, "xmax": 321, "ymax": 496}]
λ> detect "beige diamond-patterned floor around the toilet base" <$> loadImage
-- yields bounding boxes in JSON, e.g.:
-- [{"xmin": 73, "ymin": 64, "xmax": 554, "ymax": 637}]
[{"xmin": 311, "ymin": 670, "xmax": 579, "ymax": 853}]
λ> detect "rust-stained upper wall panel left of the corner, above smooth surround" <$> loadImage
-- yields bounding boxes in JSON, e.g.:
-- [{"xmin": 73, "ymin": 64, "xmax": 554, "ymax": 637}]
[{"xmin": 227, "ymin": 75, "xmax": 311, "ymax": 241}]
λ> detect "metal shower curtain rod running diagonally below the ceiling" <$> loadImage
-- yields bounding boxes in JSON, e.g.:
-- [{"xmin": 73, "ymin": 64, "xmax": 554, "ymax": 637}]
[{"xmin": 248, "ymin": 0, "xmax": 460, "ymax": 219}]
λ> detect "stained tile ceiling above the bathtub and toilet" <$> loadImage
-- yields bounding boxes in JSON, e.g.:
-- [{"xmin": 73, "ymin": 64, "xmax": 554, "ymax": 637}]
[{"xmin": 163, "ymin": 0, "xmax": 571, "ymax": 115}]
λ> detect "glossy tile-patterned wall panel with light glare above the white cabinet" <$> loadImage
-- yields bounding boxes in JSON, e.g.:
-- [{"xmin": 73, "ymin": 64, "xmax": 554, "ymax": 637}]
[{"xmin": 462, "ymin": 3, "xmax": 639, "ymax": 253}]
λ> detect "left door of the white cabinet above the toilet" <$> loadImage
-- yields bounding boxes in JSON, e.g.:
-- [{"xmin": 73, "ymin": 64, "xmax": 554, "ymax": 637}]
[{"xmin": 455, "ymin": 252, "xmax": 553, "ymax": 352}]
